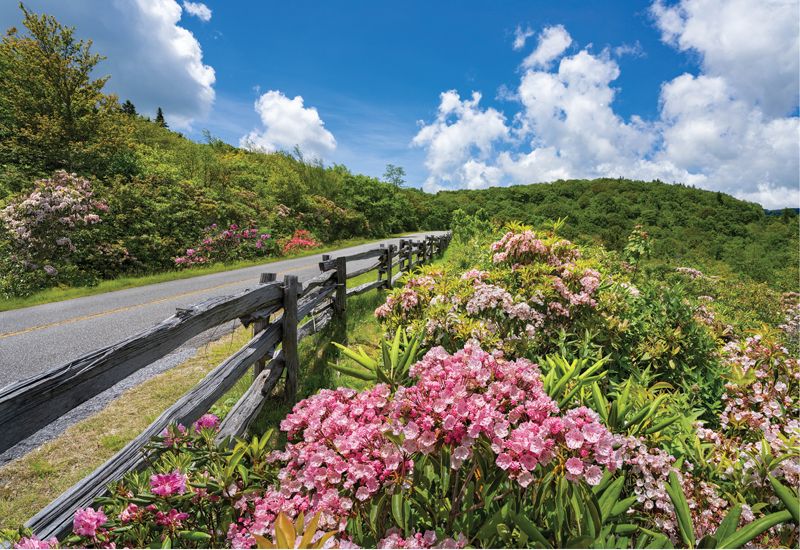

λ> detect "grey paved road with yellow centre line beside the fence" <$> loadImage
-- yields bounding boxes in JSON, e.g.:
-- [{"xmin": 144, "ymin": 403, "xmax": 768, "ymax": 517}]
[{"xmin": 0, "ymin": 232, "xmax": 444, "ymax": 387}]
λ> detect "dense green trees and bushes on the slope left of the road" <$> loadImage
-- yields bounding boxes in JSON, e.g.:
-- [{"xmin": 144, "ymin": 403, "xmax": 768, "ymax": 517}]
[{"xmin": 0, "ymin": 7, "xmax": 424, "ymax": 296}]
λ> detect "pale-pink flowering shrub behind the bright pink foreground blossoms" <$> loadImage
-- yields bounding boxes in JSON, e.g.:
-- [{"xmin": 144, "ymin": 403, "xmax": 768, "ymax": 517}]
[{"xmin": 375, "ymin": 226, "xmax": 723, "ymax": 419}]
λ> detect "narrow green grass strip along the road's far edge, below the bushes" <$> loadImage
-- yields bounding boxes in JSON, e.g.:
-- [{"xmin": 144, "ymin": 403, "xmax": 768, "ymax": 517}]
[{"xmin": 0, "ymin": 231, "xmax": 428, "ymax": 312}]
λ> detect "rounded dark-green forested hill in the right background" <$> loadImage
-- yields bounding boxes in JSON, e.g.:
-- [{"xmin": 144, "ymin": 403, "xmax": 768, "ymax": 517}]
[{"xmin": 426, "ymin": 179, "xmax": 798, "ymax": 290}]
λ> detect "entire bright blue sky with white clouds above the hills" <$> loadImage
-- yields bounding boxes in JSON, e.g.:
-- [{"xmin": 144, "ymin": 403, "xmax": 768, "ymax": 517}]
[{"xmin": 0, "ymin": 0, "xmax": 800, "ymax": 208}]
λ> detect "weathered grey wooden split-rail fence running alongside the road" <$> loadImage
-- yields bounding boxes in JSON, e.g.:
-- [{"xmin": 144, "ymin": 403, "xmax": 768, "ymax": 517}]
[{"xmin": 0, "ymin": 233, "xmax": 451, "ymax": 539}]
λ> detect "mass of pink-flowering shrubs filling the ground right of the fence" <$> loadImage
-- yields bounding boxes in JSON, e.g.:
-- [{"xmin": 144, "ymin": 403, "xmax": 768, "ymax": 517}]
[{"xmin": 4, "ymin": 217, "xmax": 800, "ymax": 548}]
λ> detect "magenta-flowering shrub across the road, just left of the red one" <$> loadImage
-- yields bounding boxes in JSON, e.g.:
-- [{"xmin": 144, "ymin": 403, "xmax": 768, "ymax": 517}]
[{"xmin": 175, "ymin": 223, "xmax": 277, "ymax": 267}]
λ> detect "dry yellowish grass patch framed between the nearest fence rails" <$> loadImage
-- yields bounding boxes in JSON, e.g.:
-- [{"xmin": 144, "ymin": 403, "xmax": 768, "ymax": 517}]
[{"xmin": 0, "ymin": 327, "xmax": 251, "ymax": 528}]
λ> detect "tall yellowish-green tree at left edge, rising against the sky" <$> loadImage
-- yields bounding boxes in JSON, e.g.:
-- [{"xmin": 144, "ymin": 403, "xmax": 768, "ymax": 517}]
[{"xmin": 0, "ymin": 6, "xmax": 129, "ymax": 175}]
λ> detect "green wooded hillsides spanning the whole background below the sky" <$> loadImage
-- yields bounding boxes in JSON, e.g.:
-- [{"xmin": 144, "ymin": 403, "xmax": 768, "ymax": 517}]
[{"xmin": 0, "ymin": 5, "xmax": 798, "ymax": 297}]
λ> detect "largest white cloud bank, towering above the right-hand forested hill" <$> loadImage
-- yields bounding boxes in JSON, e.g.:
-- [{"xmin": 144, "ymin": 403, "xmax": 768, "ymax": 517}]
[{"xmin": 412, "ymin": 0, "xmax": 800, "ymax": 208}]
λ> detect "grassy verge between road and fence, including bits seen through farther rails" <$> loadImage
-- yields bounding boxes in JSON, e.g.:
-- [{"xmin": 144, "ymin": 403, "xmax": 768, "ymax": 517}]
[{"xmin": 0, "ymin": 266, "xmax": 410, "ymax": 529}]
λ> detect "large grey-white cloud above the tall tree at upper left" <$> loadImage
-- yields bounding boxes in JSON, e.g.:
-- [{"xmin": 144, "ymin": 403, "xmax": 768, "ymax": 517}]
[{"xmin": 0, "ymin": 0, "xmax": 215, "ymax": 129}]
